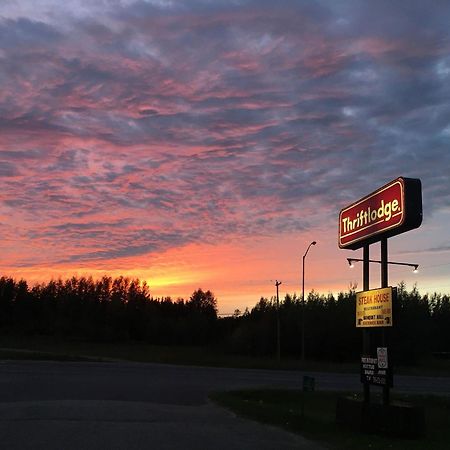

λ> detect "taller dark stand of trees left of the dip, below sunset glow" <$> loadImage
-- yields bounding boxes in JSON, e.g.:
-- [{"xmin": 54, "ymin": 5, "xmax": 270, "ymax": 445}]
[{"xmin": 0, "ymin": 277, "xmax": 217, "ymax": 345}]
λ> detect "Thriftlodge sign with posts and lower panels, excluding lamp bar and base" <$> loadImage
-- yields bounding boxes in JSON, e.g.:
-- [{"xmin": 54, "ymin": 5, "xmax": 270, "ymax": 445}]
[{"xmin": 338, "ymin": 177, "xmax": 422, "ymax": 405}]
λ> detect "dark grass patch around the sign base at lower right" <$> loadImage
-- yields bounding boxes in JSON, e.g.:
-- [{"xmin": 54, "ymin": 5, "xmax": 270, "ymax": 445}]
[{"xmin": 210, "ymin": 390, "xmax": 450, "ymax": 450}]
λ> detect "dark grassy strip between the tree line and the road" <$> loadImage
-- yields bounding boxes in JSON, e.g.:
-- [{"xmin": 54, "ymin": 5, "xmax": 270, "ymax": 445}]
[{"xmin": 0, "ymin": 336, "xmax": 450, "ymax": 376}]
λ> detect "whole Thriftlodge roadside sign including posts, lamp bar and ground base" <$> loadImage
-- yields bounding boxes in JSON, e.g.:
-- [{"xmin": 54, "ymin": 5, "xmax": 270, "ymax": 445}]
[{"xmin": 336, "ymin": 177, "xmax": 425, "ymax": 437}]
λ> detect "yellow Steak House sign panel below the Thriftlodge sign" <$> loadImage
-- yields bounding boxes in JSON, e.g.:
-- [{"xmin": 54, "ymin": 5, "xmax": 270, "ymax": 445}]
[{"xmin": 356, "ymin": 287, "xmax": 393, "ymax": 327}]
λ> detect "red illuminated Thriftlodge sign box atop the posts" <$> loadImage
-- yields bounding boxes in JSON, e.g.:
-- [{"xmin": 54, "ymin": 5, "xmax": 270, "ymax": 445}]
[{"xmin": 339, "ymin": 178, "xmax": 422, "ymax": 250}]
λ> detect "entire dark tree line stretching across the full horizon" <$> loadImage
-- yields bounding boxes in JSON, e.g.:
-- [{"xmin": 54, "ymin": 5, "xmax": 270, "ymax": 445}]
[{"xmin": 0, "ymin": 277, "xmax": 450, "ymax": 363}]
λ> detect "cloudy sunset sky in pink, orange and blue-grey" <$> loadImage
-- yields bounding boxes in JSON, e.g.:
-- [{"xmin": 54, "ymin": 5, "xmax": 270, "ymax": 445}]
[{"xmin": 0, "ymin": 0, "xmax": 450, "ymax": 314}]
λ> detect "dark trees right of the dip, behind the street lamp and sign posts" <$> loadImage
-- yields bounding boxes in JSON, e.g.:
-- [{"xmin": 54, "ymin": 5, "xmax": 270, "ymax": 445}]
[{"xmin": 226, "ymin": 283, "xmax": 450, "ymax": 364}]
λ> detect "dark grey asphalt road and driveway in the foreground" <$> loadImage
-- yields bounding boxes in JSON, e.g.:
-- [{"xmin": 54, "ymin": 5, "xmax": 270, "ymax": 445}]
[{"xmin": 0, "ymin": 361, "xmax": 450, "ymax": 450}]
